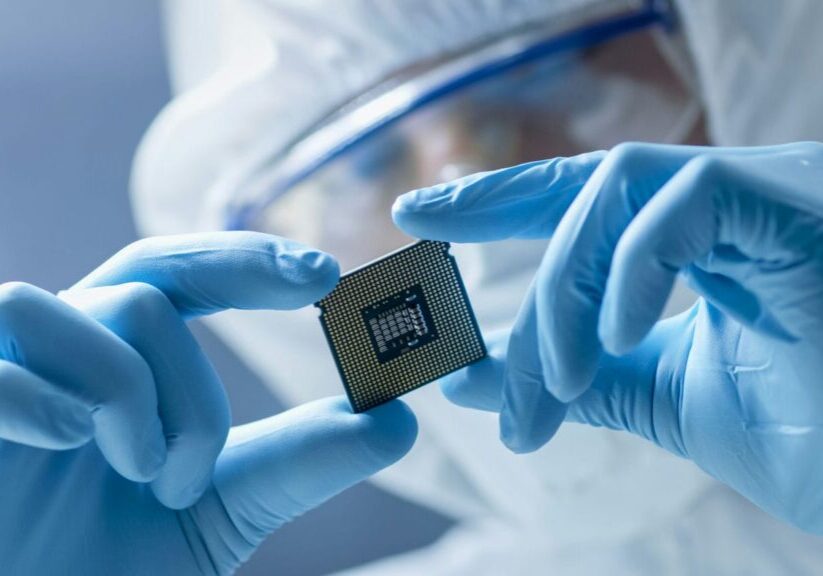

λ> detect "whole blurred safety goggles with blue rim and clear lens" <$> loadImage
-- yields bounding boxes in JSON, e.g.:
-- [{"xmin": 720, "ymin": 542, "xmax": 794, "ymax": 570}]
[{"xmin": 226, "ymin": 3, "xmax": 702, "ymax": 270}]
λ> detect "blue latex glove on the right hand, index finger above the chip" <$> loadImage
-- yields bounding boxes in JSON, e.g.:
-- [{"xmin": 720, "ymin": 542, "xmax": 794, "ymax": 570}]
[{"xmin": 395, "ymin": 143, "xmax": 823, "ymax": 533}]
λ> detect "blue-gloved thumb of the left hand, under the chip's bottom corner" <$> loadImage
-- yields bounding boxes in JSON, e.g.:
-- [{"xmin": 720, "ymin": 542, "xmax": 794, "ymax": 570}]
[{"xmin": 189, "ymin": 398, "xmax": 417, "ymax": 573}]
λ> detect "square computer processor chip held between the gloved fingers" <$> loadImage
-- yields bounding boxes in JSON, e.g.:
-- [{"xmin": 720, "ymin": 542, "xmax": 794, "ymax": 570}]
[{"xmin": 315, "ymin": 240, "xmax": 486, "ymax": 412}]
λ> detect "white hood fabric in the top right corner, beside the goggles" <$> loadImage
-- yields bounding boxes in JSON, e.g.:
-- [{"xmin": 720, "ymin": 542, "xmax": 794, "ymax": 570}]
[{"xmin": 678, "ymin": 0, "xmax": 823, "ymax": 146}]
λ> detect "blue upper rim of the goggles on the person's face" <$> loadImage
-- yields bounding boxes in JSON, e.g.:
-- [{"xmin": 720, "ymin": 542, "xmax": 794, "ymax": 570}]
[{"xmin": 225, "ymin": 0, "xmax": 674, "ymax": 230}]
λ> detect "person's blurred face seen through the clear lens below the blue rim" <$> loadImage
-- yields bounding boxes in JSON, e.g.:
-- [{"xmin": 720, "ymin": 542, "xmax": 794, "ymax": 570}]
[{"xmin": 255, "ymin": 32, "xmax": 703, "ymax": 270}]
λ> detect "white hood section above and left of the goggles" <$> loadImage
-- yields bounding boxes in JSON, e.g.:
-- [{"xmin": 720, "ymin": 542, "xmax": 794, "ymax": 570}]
[{"xmin": 133, "ymin": 0, "xmax": 616, "ymax": 233}]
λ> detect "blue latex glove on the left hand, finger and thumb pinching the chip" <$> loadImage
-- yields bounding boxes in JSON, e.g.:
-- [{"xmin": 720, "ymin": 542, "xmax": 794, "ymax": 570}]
[{"xmin": 0, "ymin": 233, "xmax": 417, "ymax": 575}]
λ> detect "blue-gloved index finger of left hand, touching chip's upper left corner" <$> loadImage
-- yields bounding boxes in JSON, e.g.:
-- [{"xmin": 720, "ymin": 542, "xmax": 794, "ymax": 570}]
[{"xmin": 73, "ymin": 232, "xmax": 340, "ymax": 317}]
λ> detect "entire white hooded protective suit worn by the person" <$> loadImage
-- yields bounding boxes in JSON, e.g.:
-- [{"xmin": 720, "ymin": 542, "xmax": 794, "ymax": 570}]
[{"xmin": 133, "ymin": 0, "xmax": 823, "ymax": 575}]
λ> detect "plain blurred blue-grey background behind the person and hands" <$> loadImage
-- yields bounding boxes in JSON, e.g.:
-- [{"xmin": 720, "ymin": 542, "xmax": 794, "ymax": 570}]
[{"xmin": 0, "ymin": 0, "xmax": 450, "ymax": 576}]
